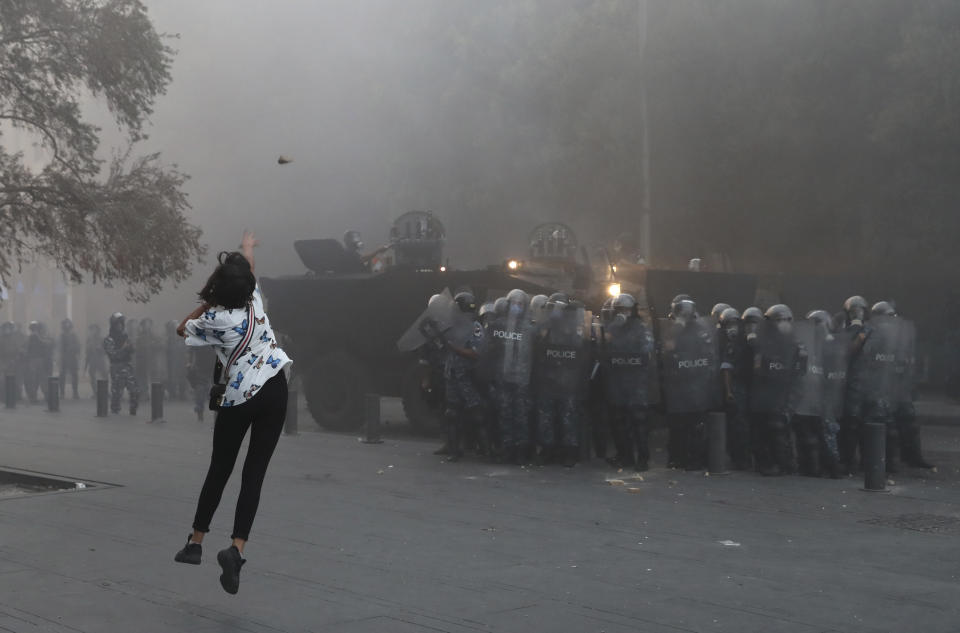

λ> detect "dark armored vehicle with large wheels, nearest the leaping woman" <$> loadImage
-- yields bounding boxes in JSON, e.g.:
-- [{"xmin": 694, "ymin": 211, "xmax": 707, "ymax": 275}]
[{"xmin": 261, "ymin": 211, "xmax": 555, "ymax": 430}]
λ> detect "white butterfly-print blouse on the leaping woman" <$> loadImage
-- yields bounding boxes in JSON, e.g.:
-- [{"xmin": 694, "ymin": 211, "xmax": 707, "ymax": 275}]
[{"xmin": 186, "ymin": 284, "xmax": 293, "ymax": 407}]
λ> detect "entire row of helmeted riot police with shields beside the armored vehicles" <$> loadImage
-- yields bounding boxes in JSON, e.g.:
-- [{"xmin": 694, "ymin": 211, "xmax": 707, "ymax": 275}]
[{"xmin": 404, "ymin": 290, "xmax": 930, "ymax": 477}]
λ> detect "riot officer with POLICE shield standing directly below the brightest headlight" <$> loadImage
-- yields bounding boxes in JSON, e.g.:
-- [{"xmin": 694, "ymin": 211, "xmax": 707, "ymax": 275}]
[{"xmin": 600, "ymin": 294, "xmax": 655, "ymax": 472}]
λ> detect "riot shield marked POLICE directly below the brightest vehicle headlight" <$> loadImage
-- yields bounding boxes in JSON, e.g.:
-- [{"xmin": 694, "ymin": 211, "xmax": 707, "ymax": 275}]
[{"xmin": 600, "ymin": 318, "xmax": 659, "ymax": 405}]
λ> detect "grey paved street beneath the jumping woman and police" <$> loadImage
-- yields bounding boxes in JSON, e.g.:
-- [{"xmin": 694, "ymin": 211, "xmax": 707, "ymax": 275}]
[{"xmin": 0, "ymin": 400, "xmax": 960, "ymax": 633}]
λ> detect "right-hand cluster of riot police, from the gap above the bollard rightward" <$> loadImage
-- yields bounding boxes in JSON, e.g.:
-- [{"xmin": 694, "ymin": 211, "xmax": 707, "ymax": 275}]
[{"xmin": 712, "ymin": 296, "xmax": 932, "ymax": 478}]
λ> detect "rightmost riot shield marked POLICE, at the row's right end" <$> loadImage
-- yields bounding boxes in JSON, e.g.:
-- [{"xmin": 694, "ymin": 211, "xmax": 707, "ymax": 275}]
[{"xmin": 861, "ymin": 316, "xmax": 905, "ymax": 407}]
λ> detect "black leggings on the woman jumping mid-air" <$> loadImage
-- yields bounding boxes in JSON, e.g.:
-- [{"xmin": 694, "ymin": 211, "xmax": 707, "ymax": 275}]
[{"xmin": 193, "ymin": 371, "xmax": 287, "ymax": 540}]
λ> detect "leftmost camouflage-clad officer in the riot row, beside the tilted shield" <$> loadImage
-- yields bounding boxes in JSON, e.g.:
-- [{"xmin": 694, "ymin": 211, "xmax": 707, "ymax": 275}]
[{"xmin": 443, "ymin": 292, "xmax": 489, "ymax": 462}]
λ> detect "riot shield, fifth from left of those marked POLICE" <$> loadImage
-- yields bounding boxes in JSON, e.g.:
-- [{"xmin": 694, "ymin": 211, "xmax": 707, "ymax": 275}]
[{"xmin": 750, "ymin": 321, "xmax": 805, "ymax": 413}]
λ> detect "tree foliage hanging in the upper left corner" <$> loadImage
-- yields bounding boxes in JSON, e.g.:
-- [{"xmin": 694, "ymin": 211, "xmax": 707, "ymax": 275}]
[{"xmin": 0, "ymin": 0, "xmax": 204, "ymax": 300}]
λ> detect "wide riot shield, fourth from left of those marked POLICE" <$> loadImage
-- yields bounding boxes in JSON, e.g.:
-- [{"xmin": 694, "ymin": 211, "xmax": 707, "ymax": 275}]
[{"xmin": 660, "ymin": 317, "xmax": 721, "ymax": 413}]
